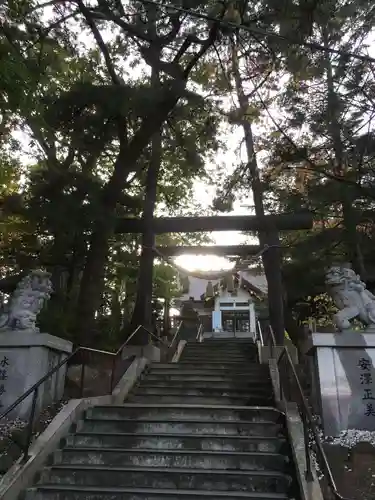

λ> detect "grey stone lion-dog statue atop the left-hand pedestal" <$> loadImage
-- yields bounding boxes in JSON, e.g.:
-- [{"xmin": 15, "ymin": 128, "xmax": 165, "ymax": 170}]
[{"xmin": 0, "ymin": 270, "xmax": 52, "ymax": 333}]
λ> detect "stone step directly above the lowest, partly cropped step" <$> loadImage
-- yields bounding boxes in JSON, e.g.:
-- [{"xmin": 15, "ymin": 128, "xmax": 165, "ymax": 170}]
[{"xmin": 40, "ymin": 464, "xmax": 291, "ymax": 494}]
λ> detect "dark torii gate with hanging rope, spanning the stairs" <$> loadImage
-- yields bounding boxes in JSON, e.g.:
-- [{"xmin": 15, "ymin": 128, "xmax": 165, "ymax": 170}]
[{"xmin": 116, "ymin": 211, "xmax": 313, "ymax": 344}]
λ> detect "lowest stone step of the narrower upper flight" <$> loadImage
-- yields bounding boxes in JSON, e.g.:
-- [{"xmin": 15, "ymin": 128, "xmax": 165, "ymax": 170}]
[{"xmin": 126, "ymin": 389, "xmax": 274, "ymax": 406}]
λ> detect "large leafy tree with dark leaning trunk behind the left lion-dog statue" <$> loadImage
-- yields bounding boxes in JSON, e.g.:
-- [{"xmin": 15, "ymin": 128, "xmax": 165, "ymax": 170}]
[{"xmin": 2, "ymin": 2, "xmax": 223, "ymax": 343}]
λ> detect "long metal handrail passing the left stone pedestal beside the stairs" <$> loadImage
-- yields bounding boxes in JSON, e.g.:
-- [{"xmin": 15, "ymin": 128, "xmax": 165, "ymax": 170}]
[{"xmin": 0, "ymin": 325, "xmax": 163, "ymax": 461}]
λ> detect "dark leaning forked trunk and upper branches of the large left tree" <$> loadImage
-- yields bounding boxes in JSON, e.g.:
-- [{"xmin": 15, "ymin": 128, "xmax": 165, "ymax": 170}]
[{"xmin": 44, "ymin": 2, "xmax": 226, "ymax": 342}]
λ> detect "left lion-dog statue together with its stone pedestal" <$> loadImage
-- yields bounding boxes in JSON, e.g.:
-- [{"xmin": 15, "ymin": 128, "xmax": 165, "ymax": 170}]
[{"xmin": 0, "ymin": 270, "xmax": 73, "ymax": 418}]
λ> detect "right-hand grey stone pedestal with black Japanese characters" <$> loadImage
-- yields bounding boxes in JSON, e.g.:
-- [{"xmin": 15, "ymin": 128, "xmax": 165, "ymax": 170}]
[{"xmin": 308, "ymin": 331, "xmax": 375, "ymax": 437}]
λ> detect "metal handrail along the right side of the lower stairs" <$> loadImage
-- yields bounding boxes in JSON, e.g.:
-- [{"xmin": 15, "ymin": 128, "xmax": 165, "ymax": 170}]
[{"xmin": 268, "ymin": 325, "xmax": 353, "ymax": 500}]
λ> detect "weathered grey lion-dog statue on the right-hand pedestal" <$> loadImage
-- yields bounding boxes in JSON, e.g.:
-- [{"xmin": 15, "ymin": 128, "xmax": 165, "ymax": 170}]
[{"xmin": 325, "ymin": 266, "xmax": 375, "ymax": 331}]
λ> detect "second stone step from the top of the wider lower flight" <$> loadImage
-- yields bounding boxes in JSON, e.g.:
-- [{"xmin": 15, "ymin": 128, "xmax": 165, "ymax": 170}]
[{"xmin": 77, "ymin": 418, "xmax": 285, "ymax": 437}]
